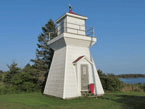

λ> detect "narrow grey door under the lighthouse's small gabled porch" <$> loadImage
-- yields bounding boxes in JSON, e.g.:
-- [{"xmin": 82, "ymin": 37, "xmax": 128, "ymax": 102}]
[{"xmin": 81, "ymin": 64, "xmax": 89, "ymax": 91}]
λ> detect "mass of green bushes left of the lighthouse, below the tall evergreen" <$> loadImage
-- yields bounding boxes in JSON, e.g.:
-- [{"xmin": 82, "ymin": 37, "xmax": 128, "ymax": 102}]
[{"xmin": 0, "ymin": 62, "xmax": 41, "ymax": 94}]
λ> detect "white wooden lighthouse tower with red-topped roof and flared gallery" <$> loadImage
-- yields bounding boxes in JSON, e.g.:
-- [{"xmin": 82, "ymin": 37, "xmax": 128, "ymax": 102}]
[{"xmin": 44, "ymin": 6, "xmax": 104, "ymax": 99}]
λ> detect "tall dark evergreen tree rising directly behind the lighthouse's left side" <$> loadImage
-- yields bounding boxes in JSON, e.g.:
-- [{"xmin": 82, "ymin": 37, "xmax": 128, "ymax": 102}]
[{"xmin": 31, "ymin": 19, "xmax": 57, "ymax": 72}]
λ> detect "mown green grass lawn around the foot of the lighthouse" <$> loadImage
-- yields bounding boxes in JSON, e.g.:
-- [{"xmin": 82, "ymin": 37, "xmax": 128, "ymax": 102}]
[{"xmin": 0, "ymin": 92, "xmax": 145, "ymax": 109}]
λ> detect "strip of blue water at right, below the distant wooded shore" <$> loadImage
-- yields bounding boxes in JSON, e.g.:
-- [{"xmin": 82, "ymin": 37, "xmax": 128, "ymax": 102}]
[{"xmin": 120, "ymin": 78, "xmax": 145, "ymax": 84}]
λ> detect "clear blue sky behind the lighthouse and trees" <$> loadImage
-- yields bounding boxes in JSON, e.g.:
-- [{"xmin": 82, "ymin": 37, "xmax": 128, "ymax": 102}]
[{"xmin": 0, "ymin": 0, "xmax": 145, "ymax": 74}]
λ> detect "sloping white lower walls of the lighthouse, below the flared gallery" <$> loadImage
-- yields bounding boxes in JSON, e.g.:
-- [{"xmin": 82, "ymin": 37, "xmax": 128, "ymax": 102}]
[{"xmin": 44, "ymin": 46, "xmax": 104, "ymax": 99}]
